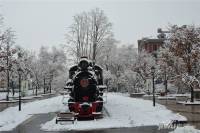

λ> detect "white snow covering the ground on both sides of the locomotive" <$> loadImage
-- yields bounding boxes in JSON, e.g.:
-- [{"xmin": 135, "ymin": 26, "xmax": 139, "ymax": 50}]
[{"xmin": 0, "ymin": 93, "xmax": 198, "ymax": 131}]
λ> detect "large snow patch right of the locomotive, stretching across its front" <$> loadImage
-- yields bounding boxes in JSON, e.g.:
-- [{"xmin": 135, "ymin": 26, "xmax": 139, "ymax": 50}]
[{"xmin": 41, "ymin": 93, "xmax": 186, "ymax": 131}]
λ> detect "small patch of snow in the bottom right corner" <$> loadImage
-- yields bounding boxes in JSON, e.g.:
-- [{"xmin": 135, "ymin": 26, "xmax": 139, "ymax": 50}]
[{"xmin": 170, "ymin": 126, "xmax": 200, "ymax": 133}]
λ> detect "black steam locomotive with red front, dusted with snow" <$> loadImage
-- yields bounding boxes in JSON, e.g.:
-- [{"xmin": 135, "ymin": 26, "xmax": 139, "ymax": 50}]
[{"xmin": 65, "ymin": 57, "xmax": 106, "ymax": 118}]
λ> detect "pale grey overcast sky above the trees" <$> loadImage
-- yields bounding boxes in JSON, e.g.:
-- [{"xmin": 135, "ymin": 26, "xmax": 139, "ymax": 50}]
[{"xmin": 0, "ymin": 0, "xmax": 200, "ymax": 50}]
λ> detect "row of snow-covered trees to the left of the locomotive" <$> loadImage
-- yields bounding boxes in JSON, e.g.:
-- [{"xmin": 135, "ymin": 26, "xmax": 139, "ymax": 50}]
[{"xmin": 0, "ymin": 15, "xmax": 67, "ymax": 100}]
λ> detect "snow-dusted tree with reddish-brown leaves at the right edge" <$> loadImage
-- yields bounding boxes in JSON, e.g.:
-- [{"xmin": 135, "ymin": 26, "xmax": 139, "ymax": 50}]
[{"xmin": 161, "ymin": 25, "xmax": 200, "ymax": 102}]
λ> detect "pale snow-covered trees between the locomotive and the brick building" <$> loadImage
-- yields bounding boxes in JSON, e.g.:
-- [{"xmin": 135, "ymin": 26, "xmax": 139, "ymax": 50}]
[{"xmin": 97, "ymin": 44, "xmax": 142, "ymax": 93}]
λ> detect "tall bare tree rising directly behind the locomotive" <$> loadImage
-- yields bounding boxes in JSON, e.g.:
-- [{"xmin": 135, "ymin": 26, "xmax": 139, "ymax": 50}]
[{"xmin": 67, "ymin": 8, "xmax": 113, "ymax": 61}]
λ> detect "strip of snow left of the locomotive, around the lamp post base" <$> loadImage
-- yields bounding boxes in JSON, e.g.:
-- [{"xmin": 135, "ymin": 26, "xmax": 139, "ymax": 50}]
[{"xmin": 0, "ymin": 96, "xmax": 65, "ymax": 131}]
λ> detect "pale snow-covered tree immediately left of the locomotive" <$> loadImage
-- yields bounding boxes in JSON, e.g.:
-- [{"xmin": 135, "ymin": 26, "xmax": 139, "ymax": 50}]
[{"xmin": 36, "ymin": 47, "xmax": 67, "ymax": 93}]
